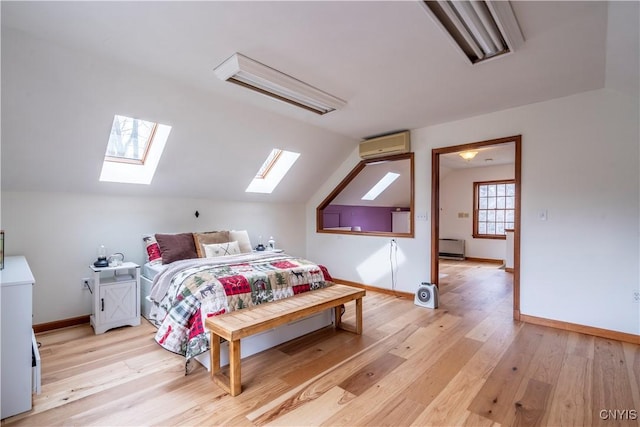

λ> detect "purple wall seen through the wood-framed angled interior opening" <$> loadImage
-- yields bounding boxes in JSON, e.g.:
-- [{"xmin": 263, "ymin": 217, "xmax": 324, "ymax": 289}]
[{"xmin": 323, "ymin": 205, "xmax": 396, "ymax": 232}]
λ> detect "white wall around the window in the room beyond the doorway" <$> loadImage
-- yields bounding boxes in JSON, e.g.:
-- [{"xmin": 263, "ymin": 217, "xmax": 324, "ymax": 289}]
[{"xmin": 440, "ymin": 165, "xmax": 515, "ymax": 260}]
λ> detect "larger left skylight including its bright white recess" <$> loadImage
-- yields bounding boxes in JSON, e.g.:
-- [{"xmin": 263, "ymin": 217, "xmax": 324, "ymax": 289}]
[{"xmin": 100, "ymin": 115, "xmax": 171, "ymax": 184}]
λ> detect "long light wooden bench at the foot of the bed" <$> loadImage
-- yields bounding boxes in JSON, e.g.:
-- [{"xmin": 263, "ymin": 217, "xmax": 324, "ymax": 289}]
[{"xmin": 205, "ymin": 284, "xmax": 365, "ymax": 396}]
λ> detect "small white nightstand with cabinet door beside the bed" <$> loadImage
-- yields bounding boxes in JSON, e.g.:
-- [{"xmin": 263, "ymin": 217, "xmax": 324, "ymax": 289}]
[{"xmin": 89, "ymin": 262, "xmax": 140, "ymax": 334}]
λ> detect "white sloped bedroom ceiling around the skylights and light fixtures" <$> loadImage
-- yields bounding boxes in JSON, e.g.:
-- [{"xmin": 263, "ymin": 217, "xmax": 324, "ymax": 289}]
[{"xmin": 1, "ymin": 1, "xmax": 607, "ymax": 202}]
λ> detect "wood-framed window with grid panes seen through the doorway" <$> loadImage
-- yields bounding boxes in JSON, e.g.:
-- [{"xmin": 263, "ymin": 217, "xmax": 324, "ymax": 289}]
[{"xmin": 473, "ymin": 180, "xmax": 516, "ymax": 239}]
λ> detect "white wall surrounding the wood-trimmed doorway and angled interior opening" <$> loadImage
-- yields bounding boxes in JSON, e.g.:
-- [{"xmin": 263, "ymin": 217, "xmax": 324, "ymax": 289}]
[{"xmin": 307, "ymin": 89, "xmax": 640, "ymax": 334}]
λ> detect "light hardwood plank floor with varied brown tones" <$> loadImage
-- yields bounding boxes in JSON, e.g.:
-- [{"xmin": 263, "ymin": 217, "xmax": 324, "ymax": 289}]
[{"xmin": 2, "ymin": 261, "xmax": 640, "ymax": 426}]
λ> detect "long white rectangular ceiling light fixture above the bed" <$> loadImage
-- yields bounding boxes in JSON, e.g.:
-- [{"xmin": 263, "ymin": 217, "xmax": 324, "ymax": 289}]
[{"xmin": 213, "ymin": 53, "xmax": 347, "ymax": 115}]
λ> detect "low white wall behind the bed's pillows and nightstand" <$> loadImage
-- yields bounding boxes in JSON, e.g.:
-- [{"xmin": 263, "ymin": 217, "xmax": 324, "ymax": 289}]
[{"xmin": 2, "ymin": 192, "xmax": 305, "ymax": 324}]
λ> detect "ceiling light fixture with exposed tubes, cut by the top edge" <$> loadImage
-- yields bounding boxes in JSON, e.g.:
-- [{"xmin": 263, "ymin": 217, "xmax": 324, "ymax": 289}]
[{"xmin": 421, "ymin": 0, "xmax": 524, "ymax": 64}]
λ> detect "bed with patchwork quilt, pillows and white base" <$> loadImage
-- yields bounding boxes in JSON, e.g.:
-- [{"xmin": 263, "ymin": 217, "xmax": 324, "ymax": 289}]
[{"xmin": 141, "ymin": 229, "xmax": 333, "ymax": 372}]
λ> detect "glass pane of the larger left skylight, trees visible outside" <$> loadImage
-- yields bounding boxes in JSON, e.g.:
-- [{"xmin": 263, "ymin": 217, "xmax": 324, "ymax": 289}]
[{"xmin": 106, "ymin": 115, "xmax": 157, "ymax": 162}]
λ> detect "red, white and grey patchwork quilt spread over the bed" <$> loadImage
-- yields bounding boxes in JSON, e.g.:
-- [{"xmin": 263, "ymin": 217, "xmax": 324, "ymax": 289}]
[{"xmin": 150, "ymin": 253, "xmax": 332, "ymax": 361}]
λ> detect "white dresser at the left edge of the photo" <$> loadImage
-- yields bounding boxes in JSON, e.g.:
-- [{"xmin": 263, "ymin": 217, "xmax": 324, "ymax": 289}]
[{"xmin": 0, "ymin": 256, "xmax": 38, "ymax": 419}]
